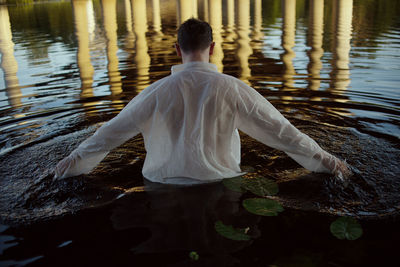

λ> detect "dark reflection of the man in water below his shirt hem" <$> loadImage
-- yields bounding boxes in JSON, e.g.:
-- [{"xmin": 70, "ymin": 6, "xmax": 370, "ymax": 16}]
[{"xmin": 111, "ymin": 181, "xmax": 260, "ymax": 257}]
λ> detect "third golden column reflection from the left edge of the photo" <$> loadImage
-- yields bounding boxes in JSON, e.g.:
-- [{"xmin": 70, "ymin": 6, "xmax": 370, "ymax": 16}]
[{"xmin": 101, "ymin": 0, "xmax": 122, "ymax": 95}]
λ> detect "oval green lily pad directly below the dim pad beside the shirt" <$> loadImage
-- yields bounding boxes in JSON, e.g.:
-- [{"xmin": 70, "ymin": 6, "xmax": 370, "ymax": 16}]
[{"xmin": 243, "ymin": 198, "xmax": 283, "ymax": 216}]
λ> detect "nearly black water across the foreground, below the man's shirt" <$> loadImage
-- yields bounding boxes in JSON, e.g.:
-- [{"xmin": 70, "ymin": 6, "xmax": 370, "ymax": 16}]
[{"xmin": 0, "ymin": 191, "xmax": 400, "ymax": 266}]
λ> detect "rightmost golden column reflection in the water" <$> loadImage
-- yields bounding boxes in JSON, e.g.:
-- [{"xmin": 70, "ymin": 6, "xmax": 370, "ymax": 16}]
[{"xmin": 332, "ymin": 0, "xmax": 353, "ymax": 90}]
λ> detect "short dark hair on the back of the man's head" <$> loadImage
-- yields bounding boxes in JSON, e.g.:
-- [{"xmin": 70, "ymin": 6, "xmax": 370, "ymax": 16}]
[{"xmin": 178, "ymin": 18, "xmax": 213, "ymax": 52}]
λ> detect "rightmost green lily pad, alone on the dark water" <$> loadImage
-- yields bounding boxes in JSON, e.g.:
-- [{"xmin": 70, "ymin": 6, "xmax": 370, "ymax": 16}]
[{"xmin": 330, "ymin": 217, "xmax": 363, "ymax": 240}]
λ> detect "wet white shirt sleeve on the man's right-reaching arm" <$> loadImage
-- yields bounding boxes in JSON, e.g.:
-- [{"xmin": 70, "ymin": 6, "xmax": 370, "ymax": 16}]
[{"xmin": 236, "ymin": 82, "xmax": 338, "ymax": 173}]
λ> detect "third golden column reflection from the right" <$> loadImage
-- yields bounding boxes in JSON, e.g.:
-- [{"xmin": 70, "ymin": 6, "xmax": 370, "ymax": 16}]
[{"xmin": 281, "ymin": 0, "xmax": 296, "ymax": 93}]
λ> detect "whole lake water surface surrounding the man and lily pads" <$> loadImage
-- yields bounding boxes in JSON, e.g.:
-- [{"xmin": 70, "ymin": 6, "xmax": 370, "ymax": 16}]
[{"xmin": 0, "ymin": 0, "xmax": 400, "ymax": 266}]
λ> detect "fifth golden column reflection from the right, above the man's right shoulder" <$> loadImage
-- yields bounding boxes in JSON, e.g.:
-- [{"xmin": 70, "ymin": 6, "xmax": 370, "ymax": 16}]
[{"xmin": 236, "ymin": 0, "xmax": 253, "ymax": 82}]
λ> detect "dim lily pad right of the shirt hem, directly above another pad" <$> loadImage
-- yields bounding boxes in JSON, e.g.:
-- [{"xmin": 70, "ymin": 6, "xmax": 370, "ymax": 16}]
[{"xmin": 243, "ymin": 176, "xmax": 279, "ymax": 197}]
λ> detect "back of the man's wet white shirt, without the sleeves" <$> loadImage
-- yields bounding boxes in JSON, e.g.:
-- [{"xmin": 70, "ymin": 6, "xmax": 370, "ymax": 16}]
[{"xmin": 139, "ymin": 62, "xmax": 240, "ymax": 182}]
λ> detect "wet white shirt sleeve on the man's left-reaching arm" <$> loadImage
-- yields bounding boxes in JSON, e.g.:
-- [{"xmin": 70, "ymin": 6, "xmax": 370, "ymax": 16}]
[{"xmin": 55, "ymin": 88, "xmax": 153, "ymax": 178}]
